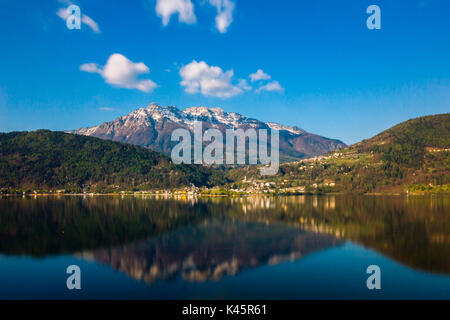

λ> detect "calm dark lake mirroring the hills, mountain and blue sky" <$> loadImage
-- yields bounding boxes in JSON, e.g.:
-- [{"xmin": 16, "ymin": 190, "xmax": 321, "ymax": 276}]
[{"xmin": 0, "ymin": 195, "xmax": 450, "ymax": 299}]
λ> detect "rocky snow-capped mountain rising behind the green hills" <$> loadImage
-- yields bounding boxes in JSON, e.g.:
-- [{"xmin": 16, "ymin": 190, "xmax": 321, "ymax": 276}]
[{"xmin": 71, "ymin": 103, "xmax": 346, "ymax": 160}]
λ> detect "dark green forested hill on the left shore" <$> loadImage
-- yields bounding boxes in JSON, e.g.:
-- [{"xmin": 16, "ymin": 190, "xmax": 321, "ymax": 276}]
[{"xmin": 0, "ymin": 130, "xmax": 222, "ymax": 192}]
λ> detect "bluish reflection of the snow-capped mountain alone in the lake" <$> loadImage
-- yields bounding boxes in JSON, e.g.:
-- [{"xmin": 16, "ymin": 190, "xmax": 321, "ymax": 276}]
[{"xmin": 81, "ymin": 221, "xmax": 341, "ymax": 284}]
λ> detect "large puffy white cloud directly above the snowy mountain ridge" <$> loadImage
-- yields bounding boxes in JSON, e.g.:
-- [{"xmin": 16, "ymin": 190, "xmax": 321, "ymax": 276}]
[{"xmin": 180, "ymin": 60, "xmax": 243, "ymax": 98}]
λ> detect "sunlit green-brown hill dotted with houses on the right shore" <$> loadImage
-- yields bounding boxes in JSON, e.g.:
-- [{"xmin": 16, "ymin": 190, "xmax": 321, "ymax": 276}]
[{"xmin": 225, "ymin": 114, "xmax": 450, "ymax": 193}]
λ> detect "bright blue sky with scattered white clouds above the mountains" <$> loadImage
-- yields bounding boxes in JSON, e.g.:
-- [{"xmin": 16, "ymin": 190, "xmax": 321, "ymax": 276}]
[{"xmin": 0, "ymin": 0, "xmax": 450, "ymax": 143}]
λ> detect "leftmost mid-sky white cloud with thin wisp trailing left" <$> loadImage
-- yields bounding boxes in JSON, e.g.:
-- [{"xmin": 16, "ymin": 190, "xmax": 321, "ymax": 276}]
[{"xmin": 80, "ymin": 53, "xmax": 158, "ymax": 92}]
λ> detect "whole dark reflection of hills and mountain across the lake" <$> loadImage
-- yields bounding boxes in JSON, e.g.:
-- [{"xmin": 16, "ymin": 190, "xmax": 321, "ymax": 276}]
[{"xmin": 0, "ymin": 196, "xmax": 450, "ymax": 284}]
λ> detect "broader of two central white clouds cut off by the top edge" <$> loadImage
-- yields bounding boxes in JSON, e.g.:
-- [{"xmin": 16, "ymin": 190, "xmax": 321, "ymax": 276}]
[{"xmin": 155, "ymin": 0, "xmax": 197, "ymax": 26}]
